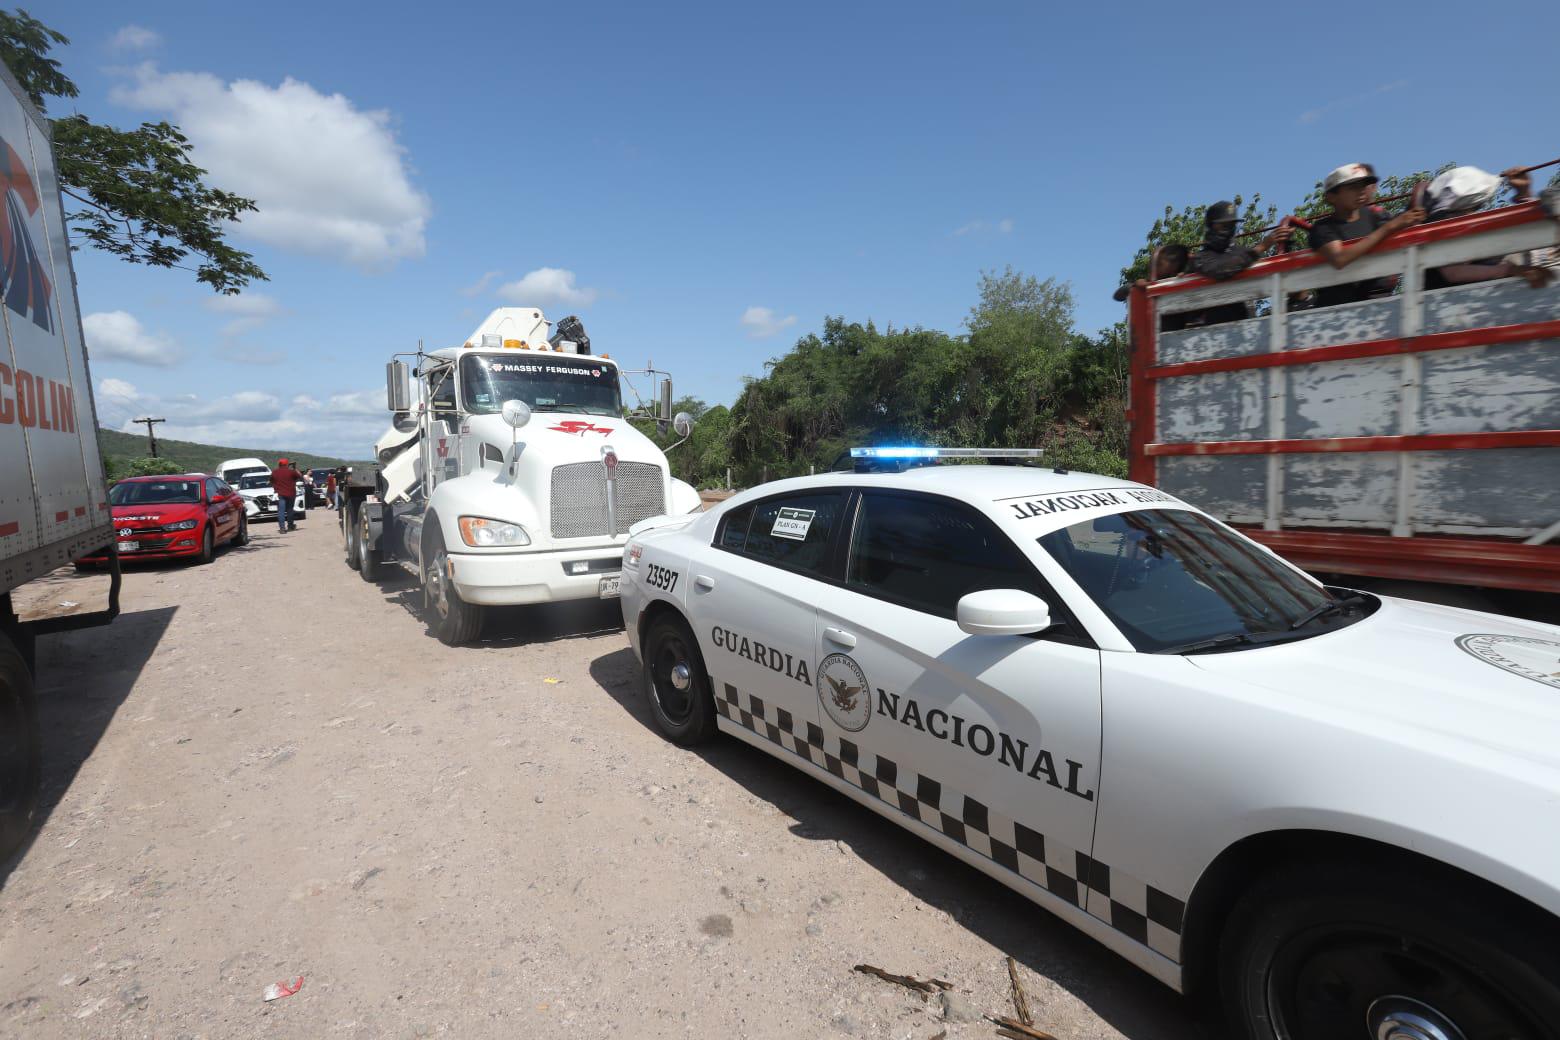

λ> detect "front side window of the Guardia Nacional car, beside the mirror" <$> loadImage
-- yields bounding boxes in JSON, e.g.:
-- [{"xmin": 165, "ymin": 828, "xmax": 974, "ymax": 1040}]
[{"xmin": 846, "ymin": 491, "xmax": 1056, "ymax": 619}]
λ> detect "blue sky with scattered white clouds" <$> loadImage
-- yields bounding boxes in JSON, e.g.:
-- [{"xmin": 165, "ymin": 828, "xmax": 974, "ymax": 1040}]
[{"xmin": 30, "ymin": 0, "xmax": 1560, "ymax": 455}]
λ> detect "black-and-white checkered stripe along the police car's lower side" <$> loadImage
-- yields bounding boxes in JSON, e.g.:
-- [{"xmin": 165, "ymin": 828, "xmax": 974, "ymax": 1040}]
[{"xmin": 714, "ymin": 683, "xmax": 1186, "ymax": 960}]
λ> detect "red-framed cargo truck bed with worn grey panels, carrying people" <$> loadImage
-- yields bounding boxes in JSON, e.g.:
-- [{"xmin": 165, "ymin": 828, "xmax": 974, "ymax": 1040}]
[{"xmin": 1128, "ymin": 203, "xmax": 1560, "ymax": 593}]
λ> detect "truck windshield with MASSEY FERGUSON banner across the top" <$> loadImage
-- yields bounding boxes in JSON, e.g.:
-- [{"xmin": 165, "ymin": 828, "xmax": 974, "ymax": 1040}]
[{"xmin": 460, "ymin": 352, "xmax": 622, "ymax": 416}]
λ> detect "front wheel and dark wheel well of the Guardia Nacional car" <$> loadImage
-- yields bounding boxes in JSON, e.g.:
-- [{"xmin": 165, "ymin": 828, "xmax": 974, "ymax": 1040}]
[{"xmin": 1220, "ymin": 865, "xmax": 1560, "ymax": 1040}]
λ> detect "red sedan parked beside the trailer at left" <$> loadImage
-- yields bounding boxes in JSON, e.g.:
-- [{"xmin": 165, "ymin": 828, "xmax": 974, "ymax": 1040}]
[{"xmin": 76, "ymin": 472, "xmax": 250, "ymax": 566}]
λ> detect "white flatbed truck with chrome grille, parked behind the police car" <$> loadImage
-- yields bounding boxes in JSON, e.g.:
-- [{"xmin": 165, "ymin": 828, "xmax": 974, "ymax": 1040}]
[{"xmin": 349, "ymin": 307, "xmax": 700, "ymax": 646}]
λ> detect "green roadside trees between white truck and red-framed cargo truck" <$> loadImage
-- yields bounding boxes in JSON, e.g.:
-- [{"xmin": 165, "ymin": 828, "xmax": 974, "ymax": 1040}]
[{"xmin": 639, "ymin": 268, "xmax": 1126, "ymax": 488}]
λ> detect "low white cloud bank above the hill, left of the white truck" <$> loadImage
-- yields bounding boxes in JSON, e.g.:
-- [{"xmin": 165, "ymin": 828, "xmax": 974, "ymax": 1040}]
[{"xmin": 97, "ymin": 379, "xmax": 388, "ymax": 458}]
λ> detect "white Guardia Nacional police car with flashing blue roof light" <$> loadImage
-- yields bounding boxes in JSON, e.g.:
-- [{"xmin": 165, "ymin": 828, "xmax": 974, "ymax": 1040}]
[{"xmin": 622, "ymin": 449, "xmax": 1560, "ymax": 1040}]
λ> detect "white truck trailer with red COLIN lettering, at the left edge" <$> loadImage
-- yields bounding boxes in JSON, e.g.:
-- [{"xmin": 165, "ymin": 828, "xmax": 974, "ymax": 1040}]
[{"xmin": 0, "ymin": 67, "xmax": 120, "ymax": 861}]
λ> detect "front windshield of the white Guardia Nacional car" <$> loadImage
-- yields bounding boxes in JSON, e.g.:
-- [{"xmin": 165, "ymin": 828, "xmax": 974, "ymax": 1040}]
[{"xmin": 1039, "ymin": 510, "xmax": 1345, "ymax": 653}]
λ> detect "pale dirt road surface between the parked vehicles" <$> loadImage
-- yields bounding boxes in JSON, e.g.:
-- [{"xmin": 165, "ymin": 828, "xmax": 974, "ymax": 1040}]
[{"xmin": 0, "ymin": 511, "xmax": 1197, "ymax": 1040}]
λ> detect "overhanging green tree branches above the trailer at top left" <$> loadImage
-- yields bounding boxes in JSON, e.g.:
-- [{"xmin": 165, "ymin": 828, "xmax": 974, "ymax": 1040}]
[{"xmin": 0, "ymin": 8, "xmax": 265, "ymax": 295}]
